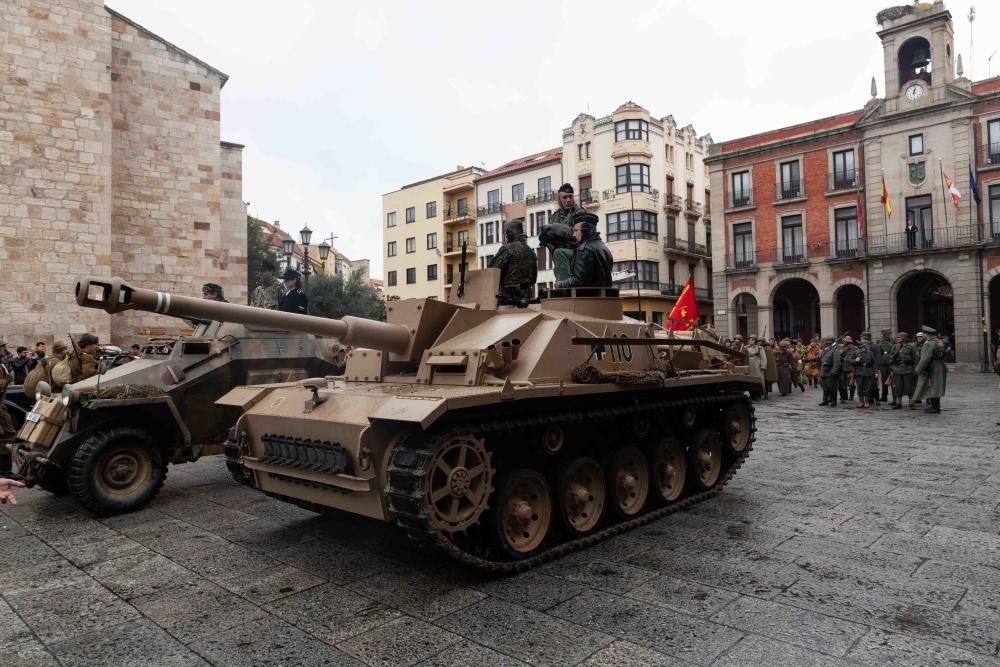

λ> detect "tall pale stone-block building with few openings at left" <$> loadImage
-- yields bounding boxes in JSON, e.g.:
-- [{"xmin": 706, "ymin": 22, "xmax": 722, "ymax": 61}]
[{"xmin": 0, "ymin": 0, "xmax": 246, "ymax": 342}]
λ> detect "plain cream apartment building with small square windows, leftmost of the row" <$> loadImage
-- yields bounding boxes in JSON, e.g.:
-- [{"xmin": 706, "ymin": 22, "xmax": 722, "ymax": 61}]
[{"xmin": 382, "ymin": 166, "xmax": 483, "ymax": 299}]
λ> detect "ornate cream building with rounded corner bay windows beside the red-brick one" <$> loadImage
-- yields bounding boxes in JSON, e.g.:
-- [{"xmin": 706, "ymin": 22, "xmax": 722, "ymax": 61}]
[{"xmin": 562, "ymin": 102, "xmax": 713, "ymax": 325}]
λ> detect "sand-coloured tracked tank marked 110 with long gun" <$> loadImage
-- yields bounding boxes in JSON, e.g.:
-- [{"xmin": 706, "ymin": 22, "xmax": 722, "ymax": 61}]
[{"xmin": 62, "ymin": 269, "xmax": 759, "ymax": 572}]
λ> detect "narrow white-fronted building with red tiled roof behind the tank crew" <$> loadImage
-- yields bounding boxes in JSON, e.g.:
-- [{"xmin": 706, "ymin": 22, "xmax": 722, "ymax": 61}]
[{"xmin": 476, "ymin": 147, "xmax": 563, "ymax": 286}]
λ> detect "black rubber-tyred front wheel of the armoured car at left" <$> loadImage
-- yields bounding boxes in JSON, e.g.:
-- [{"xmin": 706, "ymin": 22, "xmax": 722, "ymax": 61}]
[{"xmin": 67, "ymin": 426, "xmax": 167, "ymax": 516}]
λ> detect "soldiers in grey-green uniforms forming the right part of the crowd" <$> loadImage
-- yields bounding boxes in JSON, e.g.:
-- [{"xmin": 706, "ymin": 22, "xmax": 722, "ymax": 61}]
[{"xmin": 816, "ymin": 326, "xmax": 948, "ymax": 414}]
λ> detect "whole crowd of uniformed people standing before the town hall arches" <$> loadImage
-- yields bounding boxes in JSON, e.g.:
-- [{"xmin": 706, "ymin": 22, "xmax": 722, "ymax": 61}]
[{"xmin": 725, "ymin": 326, "xmax": 948, "ymax": 414}]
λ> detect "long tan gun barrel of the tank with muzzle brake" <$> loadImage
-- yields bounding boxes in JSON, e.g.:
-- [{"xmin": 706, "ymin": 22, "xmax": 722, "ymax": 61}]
[{"xmin": 76, "ymin": 276, "xmax": 410, "ymax": 354}]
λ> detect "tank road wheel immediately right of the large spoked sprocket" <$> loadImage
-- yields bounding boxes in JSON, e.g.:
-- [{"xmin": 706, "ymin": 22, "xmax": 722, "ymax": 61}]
[{"xmin": 493, "ymin": 468, "xmax": 552, "ymax": 558}]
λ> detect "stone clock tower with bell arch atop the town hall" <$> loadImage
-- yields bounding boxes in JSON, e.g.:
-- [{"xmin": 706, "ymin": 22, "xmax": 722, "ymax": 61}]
[{"xmin": 876, "ymin": 2, "xmax": 955, "ymax": 113}]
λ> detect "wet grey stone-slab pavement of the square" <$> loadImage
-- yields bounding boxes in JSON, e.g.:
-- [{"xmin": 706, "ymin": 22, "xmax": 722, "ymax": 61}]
[{"xmin": 0, "ymin": 374, "xmax": 1000, "ymax": 666}]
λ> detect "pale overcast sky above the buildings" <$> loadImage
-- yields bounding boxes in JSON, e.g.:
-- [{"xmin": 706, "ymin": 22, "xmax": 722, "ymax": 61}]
[{"xmin": 108, "ymin": 0, "xmax": 1000, "ymax": 276}]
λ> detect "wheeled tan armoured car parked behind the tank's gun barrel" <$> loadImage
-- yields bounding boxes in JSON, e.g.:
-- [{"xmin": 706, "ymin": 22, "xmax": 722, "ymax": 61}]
[{"xmin": 4, "ymin": 281, "xmax": 344, "ymax": 515}]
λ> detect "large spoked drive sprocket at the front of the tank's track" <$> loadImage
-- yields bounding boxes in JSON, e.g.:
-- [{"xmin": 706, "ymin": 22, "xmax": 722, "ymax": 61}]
[{"xmin": 424, "ymin": 435, "xmax": 493, "ymax": 533}]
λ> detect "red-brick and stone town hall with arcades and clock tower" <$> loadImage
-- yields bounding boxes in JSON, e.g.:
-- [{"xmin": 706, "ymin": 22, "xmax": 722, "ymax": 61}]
[{"xmin": 707, "ymin": 2, "xmax": 1000, "ymax": 366}]
